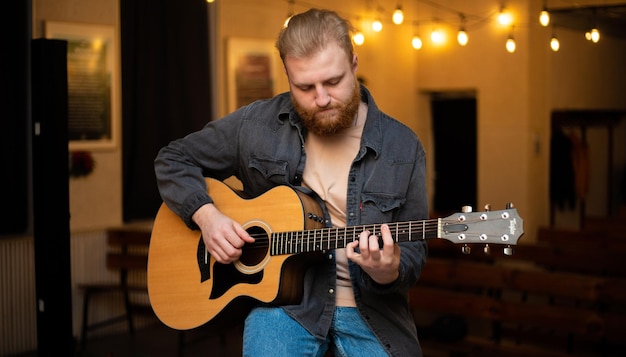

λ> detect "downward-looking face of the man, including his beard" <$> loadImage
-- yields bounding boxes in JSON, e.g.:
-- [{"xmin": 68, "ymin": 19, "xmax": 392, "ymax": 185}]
[{"xmin": 285, "ymin": 43, "xmax": 361, "ymax": 135}]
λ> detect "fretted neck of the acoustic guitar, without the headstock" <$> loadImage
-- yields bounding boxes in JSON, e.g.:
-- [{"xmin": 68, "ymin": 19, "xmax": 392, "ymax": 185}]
[{"xmin": 270, "ymin": 218, "xmax": 442, "ymax": 255}]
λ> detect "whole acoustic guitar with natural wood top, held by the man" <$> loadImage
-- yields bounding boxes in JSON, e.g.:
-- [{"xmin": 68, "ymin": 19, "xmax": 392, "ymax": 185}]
[{"xmin": 148, "ymin": 178, "xmax": 523, "ymax": 330}]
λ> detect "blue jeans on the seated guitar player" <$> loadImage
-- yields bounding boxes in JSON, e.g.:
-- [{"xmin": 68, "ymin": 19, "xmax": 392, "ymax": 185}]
[{"xmin": 243, "ymin": 307, "xmax": 388, "ymax": 357}]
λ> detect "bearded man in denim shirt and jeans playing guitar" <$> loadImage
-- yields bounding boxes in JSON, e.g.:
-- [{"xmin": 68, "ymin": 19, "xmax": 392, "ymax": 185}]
[{"xmin": 155, "ymin": 9, "xmax": 428, "ymax": 357}]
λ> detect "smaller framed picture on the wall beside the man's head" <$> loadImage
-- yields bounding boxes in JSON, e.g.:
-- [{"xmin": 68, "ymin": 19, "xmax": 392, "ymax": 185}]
[{"xmin": 226, "ymin": 38, "xmax": 280, "ymax": 112}]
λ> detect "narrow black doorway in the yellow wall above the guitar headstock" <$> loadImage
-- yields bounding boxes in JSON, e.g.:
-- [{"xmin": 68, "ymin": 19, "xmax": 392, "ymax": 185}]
[{"xmin": 431, "ymin": 92, "xmax": 477, "ymax": 215}]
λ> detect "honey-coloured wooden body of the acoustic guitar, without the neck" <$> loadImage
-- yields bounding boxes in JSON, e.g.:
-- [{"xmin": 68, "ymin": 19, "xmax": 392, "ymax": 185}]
[{"xmin": 148, "ymin": 179, "xmax": 323, "ymax": 330}]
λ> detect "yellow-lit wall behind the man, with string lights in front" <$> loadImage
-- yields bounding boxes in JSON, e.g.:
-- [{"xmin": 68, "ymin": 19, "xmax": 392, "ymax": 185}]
[{"xmin": 33, "ymin": 0, "xmax": 626, "ymax": 240}]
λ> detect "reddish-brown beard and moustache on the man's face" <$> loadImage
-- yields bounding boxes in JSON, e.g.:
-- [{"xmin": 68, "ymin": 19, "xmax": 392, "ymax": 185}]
[{"xmin": 291, "ymin": 82, "xmax": 361, "ymax": 136}]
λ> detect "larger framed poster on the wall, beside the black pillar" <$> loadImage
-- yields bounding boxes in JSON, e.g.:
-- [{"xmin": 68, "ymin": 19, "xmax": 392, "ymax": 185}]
[{"xmin": 45, "ymin": 21, "xmax": 121, "ymax": 150}]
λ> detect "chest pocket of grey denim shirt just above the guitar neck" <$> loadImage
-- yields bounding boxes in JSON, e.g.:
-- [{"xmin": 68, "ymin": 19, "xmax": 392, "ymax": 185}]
[{"xmin": 361, "ymin": 192, "xmax": 406, "ymax": 223}]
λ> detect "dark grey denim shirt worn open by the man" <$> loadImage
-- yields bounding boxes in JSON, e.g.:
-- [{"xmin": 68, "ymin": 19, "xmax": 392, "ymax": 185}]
[{"xmin": 155, "ymin": 87, "xmax": 428, "ymax": 356}]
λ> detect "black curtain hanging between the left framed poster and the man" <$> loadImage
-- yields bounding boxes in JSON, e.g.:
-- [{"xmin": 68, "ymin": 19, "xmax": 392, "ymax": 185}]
[{"xmin": 120, "ymin": 0, "xmax": 211, "ymax": 221}]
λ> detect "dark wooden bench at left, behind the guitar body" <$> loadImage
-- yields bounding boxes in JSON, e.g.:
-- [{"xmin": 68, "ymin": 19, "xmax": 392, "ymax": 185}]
[{"xmin": 78, "ymin": 226, "xmax": 152, "ymax": 350}]
